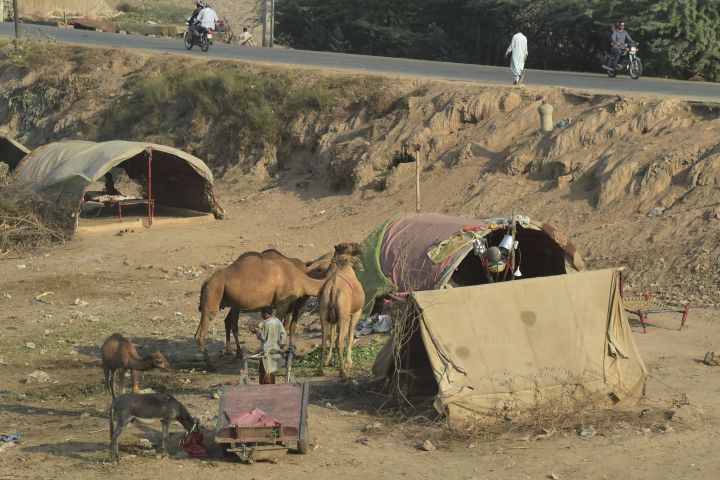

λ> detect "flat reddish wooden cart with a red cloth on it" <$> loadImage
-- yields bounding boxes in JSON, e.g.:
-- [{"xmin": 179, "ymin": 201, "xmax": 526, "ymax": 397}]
[{"xmin": 215, "ymin": 382, "xmax": 310, "ymax": 464}]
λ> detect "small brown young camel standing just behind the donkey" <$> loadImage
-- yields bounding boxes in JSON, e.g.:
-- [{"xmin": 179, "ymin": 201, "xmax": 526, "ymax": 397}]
[{"xmin": 100, "ymin": 333, "xmax": 170, "ymax": 398}]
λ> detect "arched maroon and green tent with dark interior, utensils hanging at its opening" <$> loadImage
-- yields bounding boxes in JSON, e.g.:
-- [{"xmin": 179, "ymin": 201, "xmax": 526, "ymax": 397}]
[{"xmin": 357, "ymin": 213, "xmax": 585, "ymax": 314}]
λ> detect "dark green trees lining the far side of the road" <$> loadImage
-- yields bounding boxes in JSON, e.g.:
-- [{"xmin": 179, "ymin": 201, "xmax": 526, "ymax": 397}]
[{"xmin": 276, "ymin": 0, "xmax": 720, "ymax": 81}]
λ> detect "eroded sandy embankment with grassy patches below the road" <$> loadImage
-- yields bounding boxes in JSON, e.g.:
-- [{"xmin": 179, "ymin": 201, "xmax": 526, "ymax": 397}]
[{"xmin": 0, "ymin": 45, "xmax": 720, "ymax": 305}]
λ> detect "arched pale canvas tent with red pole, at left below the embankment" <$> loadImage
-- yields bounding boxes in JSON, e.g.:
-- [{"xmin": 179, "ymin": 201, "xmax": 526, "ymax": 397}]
[{"xmin": 14, "ymin": 140, "xmax": 223, "ymax": 227}]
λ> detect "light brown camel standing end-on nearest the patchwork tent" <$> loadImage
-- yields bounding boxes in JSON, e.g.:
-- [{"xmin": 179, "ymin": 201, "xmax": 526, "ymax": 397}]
[{"xmin": 318, "ymin": 255, "xmax": 365, "ymax": 378}]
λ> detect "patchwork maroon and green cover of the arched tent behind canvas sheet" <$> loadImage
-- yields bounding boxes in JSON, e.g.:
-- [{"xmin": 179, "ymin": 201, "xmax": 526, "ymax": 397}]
[{"xmin": 356, "ymin": 213, "xmax": 585, "ymax": 314}]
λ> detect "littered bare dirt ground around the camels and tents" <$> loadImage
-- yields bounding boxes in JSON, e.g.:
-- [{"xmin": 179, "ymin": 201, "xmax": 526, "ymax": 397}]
[{"xmin": 0, "ymin": 172, "xmax": 720, "ymax": 479}]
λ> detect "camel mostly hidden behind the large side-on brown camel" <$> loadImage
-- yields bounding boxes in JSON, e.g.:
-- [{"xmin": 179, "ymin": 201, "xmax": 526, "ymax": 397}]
[{"xmin": 225, "ymin": 246, "xmax": 362, "ymax": 357}]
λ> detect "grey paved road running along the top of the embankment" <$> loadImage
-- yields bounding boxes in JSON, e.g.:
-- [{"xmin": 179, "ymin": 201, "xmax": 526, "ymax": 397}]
[{"xmin": 0, "ymin": 22, "xmax": 720, "ymax": 103}]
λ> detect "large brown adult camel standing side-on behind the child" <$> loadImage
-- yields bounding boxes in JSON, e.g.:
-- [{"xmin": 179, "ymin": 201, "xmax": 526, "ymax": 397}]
[{"xmin": 195, "ymin": 252, "xmax": 324, "ymax": 370}]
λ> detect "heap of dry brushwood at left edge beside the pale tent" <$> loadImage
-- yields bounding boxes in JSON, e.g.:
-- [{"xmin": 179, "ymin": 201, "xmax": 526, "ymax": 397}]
[{"xmin": 0, "ymin": 172, "xmax": 73, "ymax": 257}]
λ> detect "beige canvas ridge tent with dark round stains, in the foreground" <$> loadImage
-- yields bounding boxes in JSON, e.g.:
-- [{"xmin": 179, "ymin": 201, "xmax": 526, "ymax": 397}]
[{"xmin": 373, "ymin": 270, "xmax": 647, "ymax": 418}]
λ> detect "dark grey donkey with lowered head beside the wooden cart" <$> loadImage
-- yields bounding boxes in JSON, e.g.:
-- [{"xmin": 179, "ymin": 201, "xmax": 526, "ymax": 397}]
[{"xmin": 110, "ymin": 393, "xmax": 199, "ymax": 460}]
